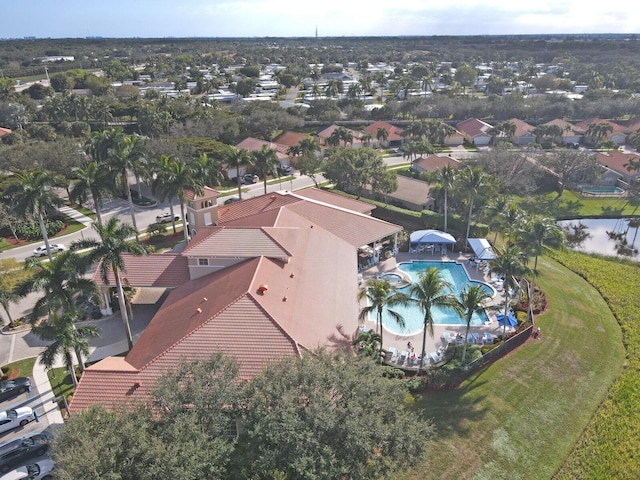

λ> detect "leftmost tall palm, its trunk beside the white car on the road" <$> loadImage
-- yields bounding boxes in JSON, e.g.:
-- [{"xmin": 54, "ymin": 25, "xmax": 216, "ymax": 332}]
[{"xmin": 5, "ymin": 168, "xmax": 62, "ymax": 261}]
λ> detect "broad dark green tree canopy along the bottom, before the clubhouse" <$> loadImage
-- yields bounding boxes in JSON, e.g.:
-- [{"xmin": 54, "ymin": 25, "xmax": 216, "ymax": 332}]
[{"xmin": 53, "ymin": 351, "xmax": 433, "ymax": 480}]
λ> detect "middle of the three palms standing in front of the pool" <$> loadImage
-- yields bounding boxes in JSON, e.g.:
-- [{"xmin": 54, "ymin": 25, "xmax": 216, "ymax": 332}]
[{"xmin": 408, "ymin": 267, "xmax": 460, "ymax": 375}]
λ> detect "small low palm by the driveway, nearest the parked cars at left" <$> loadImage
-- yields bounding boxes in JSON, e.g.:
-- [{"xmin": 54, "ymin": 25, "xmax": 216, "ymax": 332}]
[{"xmin": 32, "ymin": 311, "xmax": 100, "ymax": 386}]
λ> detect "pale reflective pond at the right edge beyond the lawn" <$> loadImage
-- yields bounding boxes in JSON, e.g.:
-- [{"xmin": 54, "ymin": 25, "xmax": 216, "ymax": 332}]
[{"xmin": 558, "ymin": 218, "xmax": 640, "ymax": 260}]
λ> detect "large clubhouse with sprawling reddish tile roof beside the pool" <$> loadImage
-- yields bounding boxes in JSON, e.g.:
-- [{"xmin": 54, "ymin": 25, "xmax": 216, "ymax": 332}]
[{"xmin": 70, "ymin": 192, "xmax": 402, "ymax": 412}]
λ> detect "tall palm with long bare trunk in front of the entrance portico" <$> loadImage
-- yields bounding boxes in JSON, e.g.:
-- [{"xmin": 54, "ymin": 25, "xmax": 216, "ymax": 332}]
[{"xmin": 71, "ymin": 217, "xmax": 148, "ymax": 349}]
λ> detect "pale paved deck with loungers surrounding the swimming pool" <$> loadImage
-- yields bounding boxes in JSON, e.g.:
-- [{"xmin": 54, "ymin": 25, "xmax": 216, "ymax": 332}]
[{"xmin": 362, "ymin": 251, "xmax": 504, "ymax": 366}]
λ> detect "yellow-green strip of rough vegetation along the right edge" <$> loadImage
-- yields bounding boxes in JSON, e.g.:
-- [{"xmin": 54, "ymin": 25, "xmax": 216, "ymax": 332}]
[{"xmin": 553, "ymin": 251, "xmax": 640, "ymax": 479}]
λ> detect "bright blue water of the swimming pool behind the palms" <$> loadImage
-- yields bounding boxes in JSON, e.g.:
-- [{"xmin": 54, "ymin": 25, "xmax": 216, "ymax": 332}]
[{"xmin": 380, "ymin": 261, "xmax": 495, "ymax": 335}]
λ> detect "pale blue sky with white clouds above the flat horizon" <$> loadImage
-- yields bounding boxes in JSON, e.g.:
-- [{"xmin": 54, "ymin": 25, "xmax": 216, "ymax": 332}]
[{"xmin": 0, "ymin": 0, "xmax": 640, "ymax": 38}]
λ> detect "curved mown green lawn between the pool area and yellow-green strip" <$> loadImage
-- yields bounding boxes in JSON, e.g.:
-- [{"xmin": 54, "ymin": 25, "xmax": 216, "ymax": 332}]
[{"xmin": 399, "ymin": 258, "xmax": 624, "ymax": 479}]
